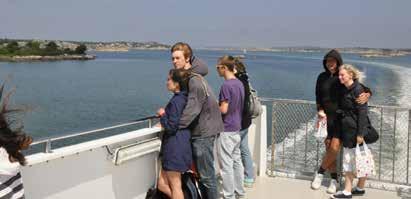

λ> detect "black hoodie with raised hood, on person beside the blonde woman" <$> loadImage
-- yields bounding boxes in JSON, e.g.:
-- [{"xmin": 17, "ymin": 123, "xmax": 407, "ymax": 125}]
[{"xmin": 315, "ymin": 50, "xmax": 343, "ymax": 115}]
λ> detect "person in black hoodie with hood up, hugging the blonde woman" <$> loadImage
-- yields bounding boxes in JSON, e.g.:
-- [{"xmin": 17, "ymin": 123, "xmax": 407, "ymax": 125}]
[{"xmin": 311, "ymin": 49, "xmax": 371, "ymax": 194}]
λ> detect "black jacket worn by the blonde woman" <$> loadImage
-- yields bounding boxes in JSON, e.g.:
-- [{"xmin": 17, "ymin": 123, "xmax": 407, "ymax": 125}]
[{"xmin": 338, "ymin": 81, "xmax": 369, "ymax": 148}]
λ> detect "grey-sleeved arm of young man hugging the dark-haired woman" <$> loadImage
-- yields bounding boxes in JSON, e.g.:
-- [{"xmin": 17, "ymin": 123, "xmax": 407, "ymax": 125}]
[{"xmin": 179, "ymin": 77, "xmax": 207, "ymax": 129}]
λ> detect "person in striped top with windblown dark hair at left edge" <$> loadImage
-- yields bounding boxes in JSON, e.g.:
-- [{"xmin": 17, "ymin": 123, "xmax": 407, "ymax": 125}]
[{"xmin": 0, "ymin": 85, "xmax": 33, "ymax": 198}]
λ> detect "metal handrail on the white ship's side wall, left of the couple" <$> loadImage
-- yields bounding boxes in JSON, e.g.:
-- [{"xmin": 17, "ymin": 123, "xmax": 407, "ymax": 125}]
[{"xmin": 30, "ymin": 116, "xmax": 158, "ymax": 153}]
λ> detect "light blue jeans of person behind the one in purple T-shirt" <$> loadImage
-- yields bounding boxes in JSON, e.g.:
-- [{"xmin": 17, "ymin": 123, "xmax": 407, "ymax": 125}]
[{"xmin": 240, "ymin": 129, "xmax": 254, "ymax": 181}]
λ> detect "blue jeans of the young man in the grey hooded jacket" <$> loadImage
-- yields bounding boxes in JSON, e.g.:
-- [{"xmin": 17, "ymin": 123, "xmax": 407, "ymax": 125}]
[{"xmin": 191, "ymin": 136, "xmax": 218, "ymax": 199}]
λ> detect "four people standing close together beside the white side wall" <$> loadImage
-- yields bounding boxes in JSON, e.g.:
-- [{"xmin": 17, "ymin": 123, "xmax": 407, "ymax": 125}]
[{"xmin": 157, "ymin": 42, "xmax": 254, "ymax": 199}]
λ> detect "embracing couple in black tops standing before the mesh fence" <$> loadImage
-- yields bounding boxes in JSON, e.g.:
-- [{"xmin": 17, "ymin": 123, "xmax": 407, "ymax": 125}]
[{"xmin": 311, "ymin": 50, "xmax": 371, "ymax": 198}]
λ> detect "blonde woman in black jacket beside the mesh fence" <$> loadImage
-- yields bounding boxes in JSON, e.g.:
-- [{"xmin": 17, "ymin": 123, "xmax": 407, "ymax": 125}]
[{"xmin": 332, "ymin": 64, "xmax": 369, "ymax": 198}]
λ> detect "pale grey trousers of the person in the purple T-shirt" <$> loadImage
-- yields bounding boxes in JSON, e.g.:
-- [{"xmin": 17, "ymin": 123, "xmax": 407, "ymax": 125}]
[{"xmin": 217, "ymin": 132, "xmax": 245, "ymax": 199}]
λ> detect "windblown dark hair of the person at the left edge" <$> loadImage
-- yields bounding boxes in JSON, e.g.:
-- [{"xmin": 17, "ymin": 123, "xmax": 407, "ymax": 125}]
[{"xmin": 0, "ymin": 84, "xmax": 33, "ymax": 165}]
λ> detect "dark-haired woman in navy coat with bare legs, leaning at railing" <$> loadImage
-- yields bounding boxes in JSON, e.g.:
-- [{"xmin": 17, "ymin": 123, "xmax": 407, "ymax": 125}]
[{"xmin": 157, "ymin": 69, "xmax": 192, "ymax": 199}]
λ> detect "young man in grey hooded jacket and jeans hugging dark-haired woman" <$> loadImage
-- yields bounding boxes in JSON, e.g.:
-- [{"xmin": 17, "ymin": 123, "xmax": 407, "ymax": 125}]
[{"xmin": 171, "ymin": 42, "xmax": 224, "ymax": 199}]
